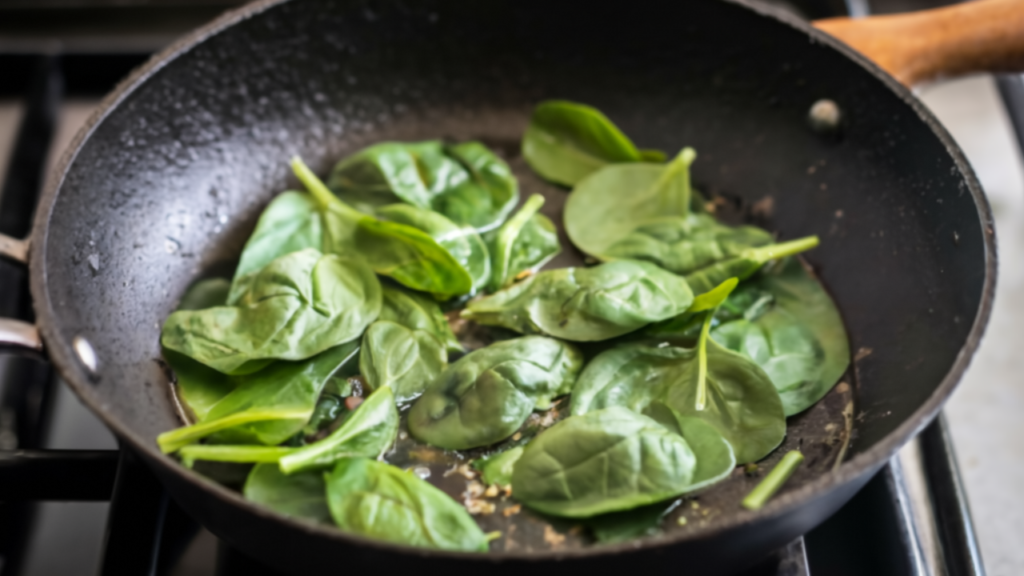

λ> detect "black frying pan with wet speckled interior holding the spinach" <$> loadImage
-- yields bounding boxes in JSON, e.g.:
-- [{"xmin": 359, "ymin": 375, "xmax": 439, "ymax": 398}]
[{"xmin": 0, "ymin": 0, "xmax": 1011, "ymax": 574}]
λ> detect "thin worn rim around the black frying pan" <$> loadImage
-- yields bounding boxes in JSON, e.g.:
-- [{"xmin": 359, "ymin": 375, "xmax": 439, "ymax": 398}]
[{"xmin": 29, "ymin": 0, "xmax": 998, "ymax": 563}]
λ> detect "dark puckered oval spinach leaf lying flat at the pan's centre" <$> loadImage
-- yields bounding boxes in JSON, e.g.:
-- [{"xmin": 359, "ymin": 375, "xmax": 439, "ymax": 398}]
[{"xmin": 409, "ymin": 336, "xmax": 583, "ymax": 450}]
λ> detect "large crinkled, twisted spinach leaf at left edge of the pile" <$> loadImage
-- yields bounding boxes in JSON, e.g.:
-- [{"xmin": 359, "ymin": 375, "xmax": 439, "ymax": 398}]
[{"xmin": 161, "ymin": 248, "xmax": 381, "ymax": 374}]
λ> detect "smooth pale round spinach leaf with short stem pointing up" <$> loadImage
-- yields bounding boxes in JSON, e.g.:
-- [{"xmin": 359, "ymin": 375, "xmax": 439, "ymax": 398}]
[{"xmin": 564, "ymin": 148, "xmax": 700, "ymax": 258}]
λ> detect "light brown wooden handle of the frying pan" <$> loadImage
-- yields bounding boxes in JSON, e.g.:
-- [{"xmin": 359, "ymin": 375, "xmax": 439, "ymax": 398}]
[{"xmin": 812, "ymin": 0, "xmax": 1024, "ymax": 86}]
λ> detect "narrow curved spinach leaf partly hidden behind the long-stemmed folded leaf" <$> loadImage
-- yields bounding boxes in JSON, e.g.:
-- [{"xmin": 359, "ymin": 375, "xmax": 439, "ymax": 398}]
[{"xmin": 377, "ymin": 204, "xmax": 490, "ymax": 291}]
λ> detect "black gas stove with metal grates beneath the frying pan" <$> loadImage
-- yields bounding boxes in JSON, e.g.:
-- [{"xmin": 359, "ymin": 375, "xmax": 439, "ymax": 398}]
[{"xmin": 0, "ymin": 0, "xmax": 1007, "ymax": 576}]
